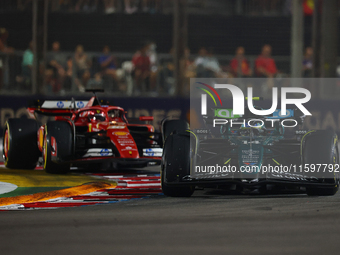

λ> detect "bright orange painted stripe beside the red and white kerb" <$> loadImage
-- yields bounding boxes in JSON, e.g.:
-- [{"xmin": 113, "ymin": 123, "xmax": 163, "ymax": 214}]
[{"xmin": 0, "ymin": 182, "xmax": 117, "ymax": 206}]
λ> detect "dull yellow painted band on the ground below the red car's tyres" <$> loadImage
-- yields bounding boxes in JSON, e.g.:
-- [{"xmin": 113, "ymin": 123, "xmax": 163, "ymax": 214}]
[{"xmin": 0, "ymin": 168, "xmax": 106, "ymax": 187}]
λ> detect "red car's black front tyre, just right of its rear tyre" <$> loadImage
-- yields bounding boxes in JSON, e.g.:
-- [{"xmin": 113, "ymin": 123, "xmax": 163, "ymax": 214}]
[{"xmin": 43, "ymin": 121, "xmax": 73, "ymax": 174}]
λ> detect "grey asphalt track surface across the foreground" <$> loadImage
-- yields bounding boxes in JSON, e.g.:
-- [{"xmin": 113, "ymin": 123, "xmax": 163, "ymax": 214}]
[{"xmin": 0, "ymin": 140, "xmax": 340, "ymax": 255}]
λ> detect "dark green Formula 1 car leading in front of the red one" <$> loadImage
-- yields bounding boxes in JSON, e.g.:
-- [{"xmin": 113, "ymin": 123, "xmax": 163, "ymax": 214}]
[{"xmin": 161, "ymin": 109, "xmax": 339, "ymax": 197}]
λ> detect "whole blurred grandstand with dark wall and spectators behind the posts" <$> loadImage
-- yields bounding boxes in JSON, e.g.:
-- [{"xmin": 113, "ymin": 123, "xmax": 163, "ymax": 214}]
[{"xmin": 0, "ymin": 0, "xmax": 340, "ymax": 96}]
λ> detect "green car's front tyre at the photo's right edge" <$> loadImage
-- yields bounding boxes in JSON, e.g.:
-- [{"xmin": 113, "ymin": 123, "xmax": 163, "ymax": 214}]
[{"xmin": 303, "ymin": 130, "xmax": 339, "ymax": 196}]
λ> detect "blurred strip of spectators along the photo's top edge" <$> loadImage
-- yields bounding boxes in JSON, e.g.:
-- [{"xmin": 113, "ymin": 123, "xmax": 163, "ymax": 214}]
[{"xmin": 0, "ymin": 0, "xmax": 332, "ymax": 16}]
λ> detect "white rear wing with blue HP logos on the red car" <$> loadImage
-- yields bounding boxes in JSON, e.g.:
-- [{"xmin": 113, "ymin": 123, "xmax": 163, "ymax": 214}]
[{"xmin": 27, "ymin": 100, "xmax": 89, "ymax": 118}]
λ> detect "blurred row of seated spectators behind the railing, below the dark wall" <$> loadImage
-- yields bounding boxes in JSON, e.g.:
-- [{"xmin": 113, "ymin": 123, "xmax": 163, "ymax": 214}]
[{"xmin": 0, "ymin": 35, "xmax": 313, "ymax": 95}]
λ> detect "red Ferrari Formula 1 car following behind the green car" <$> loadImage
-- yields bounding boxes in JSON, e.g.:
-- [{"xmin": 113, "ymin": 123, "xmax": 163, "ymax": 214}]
[{"xmin": 3, "ymin": 90, "xmax": 162, "ymax": 173}]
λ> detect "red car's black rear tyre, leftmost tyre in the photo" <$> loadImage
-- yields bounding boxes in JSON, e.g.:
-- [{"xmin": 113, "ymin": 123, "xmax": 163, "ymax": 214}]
[{"xmin": 3, "ymin": 118, "xmax": 40, "ymax": 169}]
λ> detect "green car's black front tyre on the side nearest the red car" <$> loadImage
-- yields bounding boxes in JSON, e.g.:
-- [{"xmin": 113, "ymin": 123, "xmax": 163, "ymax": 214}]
[{"xmin": 161, "ymin": 131, "xmax": 196, "ymax": 197}]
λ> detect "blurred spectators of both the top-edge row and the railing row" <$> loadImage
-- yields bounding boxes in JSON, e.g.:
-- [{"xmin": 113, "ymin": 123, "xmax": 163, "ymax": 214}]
[{"xmin": 0, "ymin": 0, "xmax": 340, "ymax": 96}]
